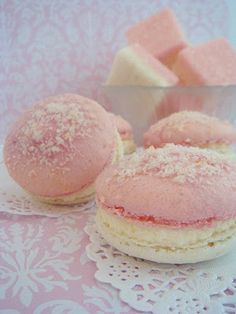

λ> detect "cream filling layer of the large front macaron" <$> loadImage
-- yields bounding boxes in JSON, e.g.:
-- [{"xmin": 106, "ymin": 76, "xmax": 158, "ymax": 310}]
[{"xmin": 96, "ymin": 208, "xmax": 236, "ymax": 251}]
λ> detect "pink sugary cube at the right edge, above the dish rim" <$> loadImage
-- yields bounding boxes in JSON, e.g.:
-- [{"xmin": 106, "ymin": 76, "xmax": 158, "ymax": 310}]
[{"xmin": 173, "ymin": 38, "xmax": 236, "ymax": 85}]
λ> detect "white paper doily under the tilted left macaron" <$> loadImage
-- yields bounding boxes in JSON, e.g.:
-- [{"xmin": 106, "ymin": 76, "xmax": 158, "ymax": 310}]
[{"xmin": 0, "ymin": 146, "xmax": 95, "ymax": 217}]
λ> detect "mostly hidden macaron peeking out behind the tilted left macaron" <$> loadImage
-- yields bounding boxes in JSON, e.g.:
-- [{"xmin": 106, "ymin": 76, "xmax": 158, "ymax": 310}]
[{"xmin": 110, "ymin": 113, "xmax": 135, "ymax": 154}]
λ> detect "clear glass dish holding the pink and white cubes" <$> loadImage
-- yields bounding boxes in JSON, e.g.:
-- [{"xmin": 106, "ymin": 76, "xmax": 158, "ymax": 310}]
[{"xmin": 102, "ymin": 85, "xmax": 236, "ymax": 144}]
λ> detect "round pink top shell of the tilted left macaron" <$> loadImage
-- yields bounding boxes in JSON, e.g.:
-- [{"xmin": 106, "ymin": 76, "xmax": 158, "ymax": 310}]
[{"xmin": 4, "ymin": 94, "xmax": 116, "ymax": 197}]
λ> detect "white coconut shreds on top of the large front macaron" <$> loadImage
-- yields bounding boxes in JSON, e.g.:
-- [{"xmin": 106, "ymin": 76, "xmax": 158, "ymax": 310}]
[{"xmin": 115, "ymin": 144, "xmax": 231, "ymax": 184}]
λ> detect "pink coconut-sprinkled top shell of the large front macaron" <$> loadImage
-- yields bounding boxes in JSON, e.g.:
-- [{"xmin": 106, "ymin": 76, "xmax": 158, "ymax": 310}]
[{"xmin": 96, "ymin": 144, "xmax": 236, "ymax": 227}]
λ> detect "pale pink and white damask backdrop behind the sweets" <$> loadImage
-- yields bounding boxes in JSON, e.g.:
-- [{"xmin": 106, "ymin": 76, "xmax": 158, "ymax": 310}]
[{"xmin": 0, "ymin": 0, "xmax": 232, "ymax": 141}]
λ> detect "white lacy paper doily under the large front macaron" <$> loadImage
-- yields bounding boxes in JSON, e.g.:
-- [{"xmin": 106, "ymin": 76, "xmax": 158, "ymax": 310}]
[{"xmin": 85, "ymin": 217, "xmax": 236, "ymax": 314}]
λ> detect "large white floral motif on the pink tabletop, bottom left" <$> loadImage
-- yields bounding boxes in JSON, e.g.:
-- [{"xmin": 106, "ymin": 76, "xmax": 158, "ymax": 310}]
[{"xmin": 0, "ymin": 219, "xmax": 83, "ymax": 307}]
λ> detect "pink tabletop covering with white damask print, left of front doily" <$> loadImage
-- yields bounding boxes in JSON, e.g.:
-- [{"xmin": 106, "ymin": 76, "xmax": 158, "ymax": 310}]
[{"xmin": 0, "ymin": 212, "xmax": 135, "ymax": 314}]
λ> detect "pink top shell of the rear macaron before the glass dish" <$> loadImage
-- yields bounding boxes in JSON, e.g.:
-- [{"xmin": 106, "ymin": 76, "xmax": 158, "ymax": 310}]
[{"xmin": 144, "ymin": 111, "xmax": 236, "ymax": 147}]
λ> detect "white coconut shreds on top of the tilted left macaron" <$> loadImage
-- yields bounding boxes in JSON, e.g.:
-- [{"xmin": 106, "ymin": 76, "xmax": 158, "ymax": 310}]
[{"xmin": 14, "ymin": 97, "xmax": 99, "ymax": 165}]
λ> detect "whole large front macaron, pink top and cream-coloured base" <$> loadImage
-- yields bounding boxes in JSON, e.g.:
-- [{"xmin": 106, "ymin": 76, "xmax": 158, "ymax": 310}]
[{"xmin": 96, "ymin": 144, "xmax": 236, "ymax": 263}]
